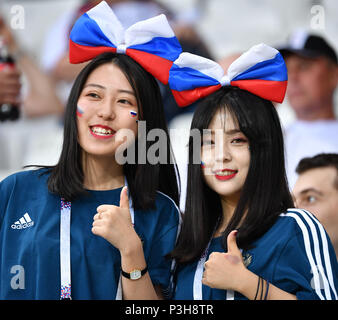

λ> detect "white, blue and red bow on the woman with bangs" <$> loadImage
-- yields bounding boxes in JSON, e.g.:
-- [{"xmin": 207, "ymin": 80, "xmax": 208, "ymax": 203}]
[{"xmin": 169, "ymin": 43, "xmax": 288, "ymax": 107}]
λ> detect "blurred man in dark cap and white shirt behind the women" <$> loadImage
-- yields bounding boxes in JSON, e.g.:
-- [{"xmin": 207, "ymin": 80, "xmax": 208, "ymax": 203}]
[{"xmin": 280, "ymin": 32, "xmax": 338, "ymax": 188}]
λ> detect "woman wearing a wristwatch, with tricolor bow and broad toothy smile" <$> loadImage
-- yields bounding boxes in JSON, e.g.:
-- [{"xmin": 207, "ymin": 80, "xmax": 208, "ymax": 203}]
[{"xmin": 0, "ymin": 2, "xmax": 181, "ymax": 300}]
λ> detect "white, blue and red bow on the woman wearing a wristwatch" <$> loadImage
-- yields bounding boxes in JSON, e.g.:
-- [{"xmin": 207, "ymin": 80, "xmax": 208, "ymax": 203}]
[{"xmin": 69, "ymin": 1, "xmax": 182, "ymax": 84}]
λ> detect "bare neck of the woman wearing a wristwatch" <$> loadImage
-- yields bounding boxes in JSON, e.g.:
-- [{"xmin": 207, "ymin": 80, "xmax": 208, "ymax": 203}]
[{"xmin": 82, "ymin": 153, "xmax": 124, "ymax": 190}]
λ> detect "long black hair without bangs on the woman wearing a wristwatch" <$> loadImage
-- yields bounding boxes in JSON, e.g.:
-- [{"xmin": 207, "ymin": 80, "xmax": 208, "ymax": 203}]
[{"xmin": 41, "ymin": 52, "xmax": 179, "ymax": 209}]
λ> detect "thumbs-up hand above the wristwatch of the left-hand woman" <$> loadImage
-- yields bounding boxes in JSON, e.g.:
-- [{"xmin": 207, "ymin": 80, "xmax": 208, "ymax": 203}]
[{"xmin": 92, "ymin": 187, "xmax": 140, "ymax": 252}]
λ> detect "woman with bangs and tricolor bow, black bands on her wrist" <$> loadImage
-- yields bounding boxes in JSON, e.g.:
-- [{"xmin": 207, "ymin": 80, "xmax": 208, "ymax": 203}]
[{"xmin": 169, "ymin": 44, "xmax": 338, "ymax": 300}]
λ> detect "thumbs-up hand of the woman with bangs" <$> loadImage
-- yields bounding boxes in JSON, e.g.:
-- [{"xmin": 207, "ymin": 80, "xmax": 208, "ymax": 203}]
[{"xmin": 202, "ymin": 230, "xmax": 248, "ymax": 291}]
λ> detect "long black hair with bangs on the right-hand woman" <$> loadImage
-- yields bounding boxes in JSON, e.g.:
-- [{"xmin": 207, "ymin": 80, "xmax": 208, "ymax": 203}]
[{"xmin": 171, "ymin": 87, "xmax": 293, "ymax": 263}]
